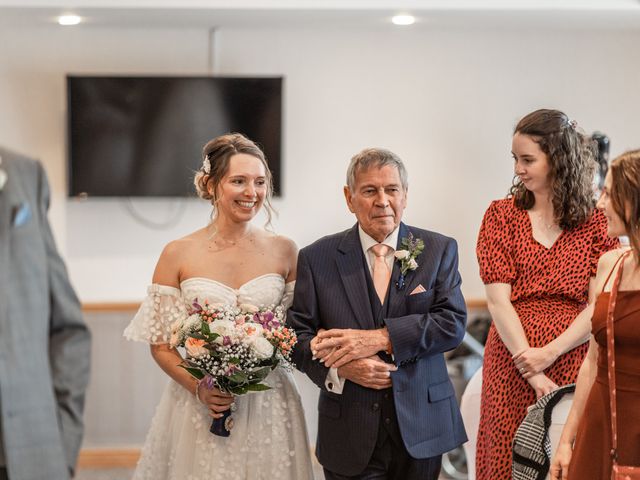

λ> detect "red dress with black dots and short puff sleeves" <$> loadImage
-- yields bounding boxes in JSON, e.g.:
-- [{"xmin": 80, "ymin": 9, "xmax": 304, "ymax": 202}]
[{"xmin": 476, "ymin": 198, "xmax": 618, "ymax": 480}]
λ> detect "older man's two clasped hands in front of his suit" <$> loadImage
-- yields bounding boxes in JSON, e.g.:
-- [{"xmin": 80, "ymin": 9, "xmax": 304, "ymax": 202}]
[{"xmin": 310, "ymin": 328, "xmax": 398, "ymax": 390}]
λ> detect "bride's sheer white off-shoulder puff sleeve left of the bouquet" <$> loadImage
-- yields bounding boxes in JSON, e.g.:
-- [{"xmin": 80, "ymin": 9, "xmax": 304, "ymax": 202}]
[{"xmin": 123, "ymin": 284, "xmax": 188, "ymax": 345}]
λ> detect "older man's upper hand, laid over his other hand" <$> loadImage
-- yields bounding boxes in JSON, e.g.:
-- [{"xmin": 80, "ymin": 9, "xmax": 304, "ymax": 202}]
[{"xmin": 311, "ymin": 328, "xmax": 391, "ymax": 368}]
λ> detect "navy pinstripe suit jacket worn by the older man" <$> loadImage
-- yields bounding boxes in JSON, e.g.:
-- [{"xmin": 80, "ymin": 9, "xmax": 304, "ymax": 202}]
[{"xmin": 288, "ymin": 223, "xmax": 466, "ymax": 475}]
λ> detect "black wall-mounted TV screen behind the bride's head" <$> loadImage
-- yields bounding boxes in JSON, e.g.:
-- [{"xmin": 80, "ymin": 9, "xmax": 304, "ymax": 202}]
[{"xmin": 67, "ymin": 76, "xmax": 282, "ymax": 197}]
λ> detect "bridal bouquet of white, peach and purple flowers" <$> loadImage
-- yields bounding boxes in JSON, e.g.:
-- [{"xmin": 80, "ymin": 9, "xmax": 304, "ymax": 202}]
[{"xmin": 170, "ymin": 299, "xmax": 296, "ymax": 436}]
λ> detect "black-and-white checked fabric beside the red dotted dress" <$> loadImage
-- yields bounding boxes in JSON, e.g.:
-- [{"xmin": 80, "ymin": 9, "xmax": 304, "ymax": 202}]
[{"xmin": 511, "ymin": 383, "xmax": 576, "ymax": 480}]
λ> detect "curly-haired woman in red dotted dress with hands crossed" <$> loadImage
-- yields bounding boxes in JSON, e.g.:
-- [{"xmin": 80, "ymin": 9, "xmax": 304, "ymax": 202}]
[{"xmin": 476, "ymin": 110, "xmax": 617, "ymax": 480}]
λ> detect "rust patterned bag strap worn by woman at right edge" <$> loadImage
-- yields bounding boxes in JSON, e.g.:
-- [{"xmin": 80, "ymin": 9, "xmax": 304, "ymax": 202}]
[{"xmin": 607, "ymin": 251, "xmax": 640, "ymax": 480}]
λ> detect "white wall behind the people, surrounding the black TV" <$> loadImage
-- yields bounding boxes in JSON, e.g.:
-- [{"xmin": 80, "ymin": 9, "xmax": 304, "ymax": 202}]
[{"xmin": 0, "ymin": 26, "xmax": 640, "ymax": 301}]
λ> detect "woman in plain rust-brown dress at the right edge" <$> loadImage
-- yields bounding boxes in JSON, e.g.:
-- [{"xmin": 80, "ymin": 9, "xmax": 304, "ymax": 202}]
[{"xmin": 551, "ymin": 150, "xmax": 640, "ymax": 480}]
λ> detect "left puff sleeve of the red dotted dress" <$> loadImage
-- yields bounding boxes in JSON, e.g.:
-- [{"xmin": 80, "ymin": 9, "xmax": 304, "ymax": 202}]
[{"xmin": 476, "ymin": 199, "xmax": 516, "ymax": 285}]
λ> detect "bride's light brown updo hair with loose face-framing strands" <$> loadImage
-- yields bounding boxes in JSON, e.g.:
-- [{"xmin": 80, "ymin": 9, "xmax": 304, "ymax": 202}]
[{"xmin": 193, "ymin": 133, "xmax": 275, "ymax": 225}]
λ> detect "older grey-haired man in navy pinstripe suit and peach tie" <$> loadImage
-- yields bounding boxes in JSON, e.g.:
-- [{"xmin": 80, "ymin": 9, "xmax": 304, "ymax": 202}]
[{"xmin": 288, "ymin": 149, "xmax": 466, "ymax": 480}]
